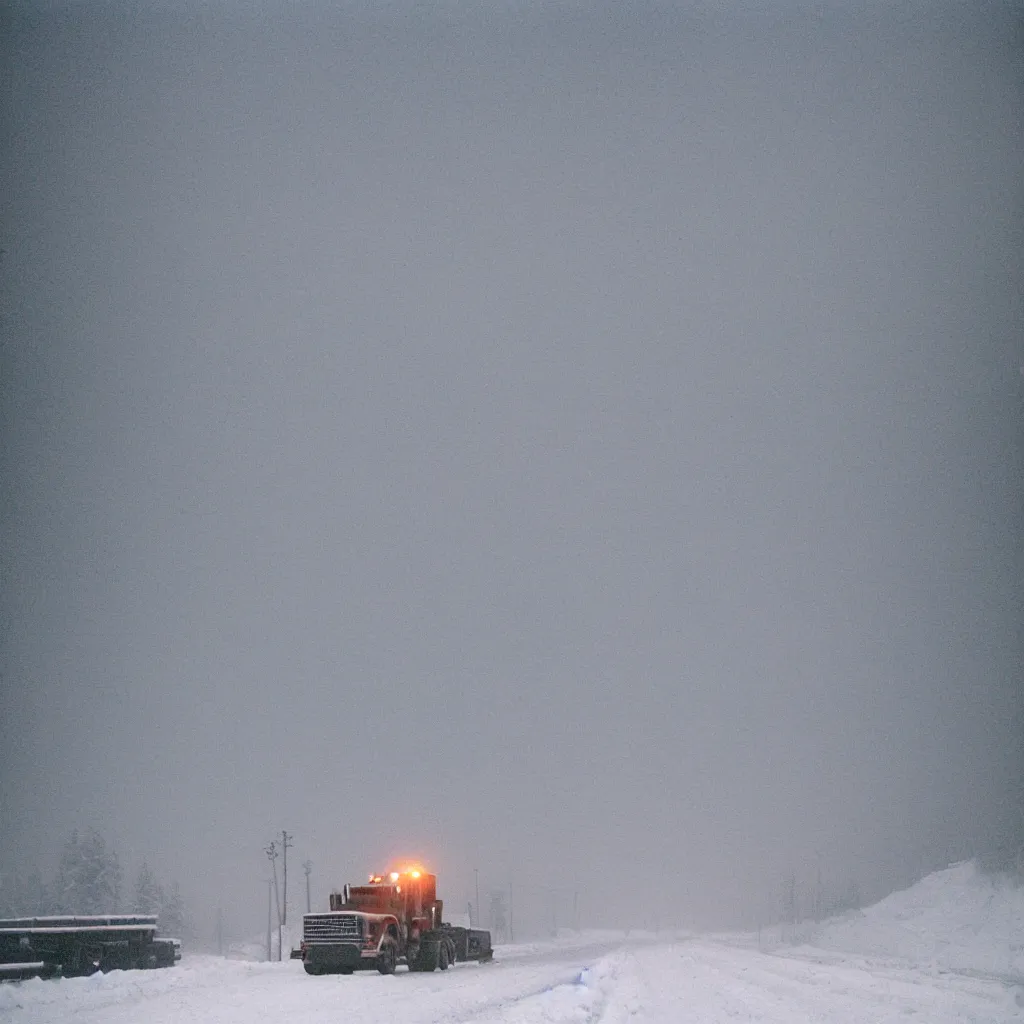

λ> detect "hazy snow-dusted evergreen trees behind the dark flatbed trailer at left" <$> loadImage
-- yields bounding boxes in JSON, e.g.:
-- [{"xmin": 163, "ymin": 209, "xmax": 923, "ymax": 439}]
[{"xmin": 0, "ymin": 828, "xmax": 191, "ymax": 938}]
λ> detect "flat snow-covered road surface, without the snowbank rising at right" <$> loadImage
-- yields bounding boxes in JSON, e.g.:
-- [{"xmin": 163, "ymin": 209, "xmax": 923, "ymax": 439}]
[{"xmin": 0, "ymin": 939, "xmax": 1024, "ymax": 1024}]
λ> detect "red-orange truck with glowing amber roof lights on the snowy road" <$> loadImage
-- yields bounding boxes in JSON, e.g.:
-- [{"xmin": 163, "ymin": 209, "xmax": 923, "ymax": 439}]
[{"xmin": 291, "ymin": 868, "xmax": 494, "ymax": 975}]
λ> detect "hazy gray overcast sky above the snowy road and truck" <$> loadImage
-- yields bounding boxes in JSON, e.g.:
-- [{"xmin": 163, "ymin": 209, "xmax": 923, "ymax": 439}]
[{"xmin": 0, "ymin": 2, "xmax": 1024, "ymax": 930}]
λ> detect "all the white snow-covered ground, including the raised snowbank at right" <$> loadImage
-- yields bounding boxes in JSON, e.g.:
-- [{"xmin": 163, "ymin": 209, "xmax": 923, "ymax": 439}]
[{"xmin": 0, "ymin": 865, "xmax": 1024, "ymax": 1024}]
